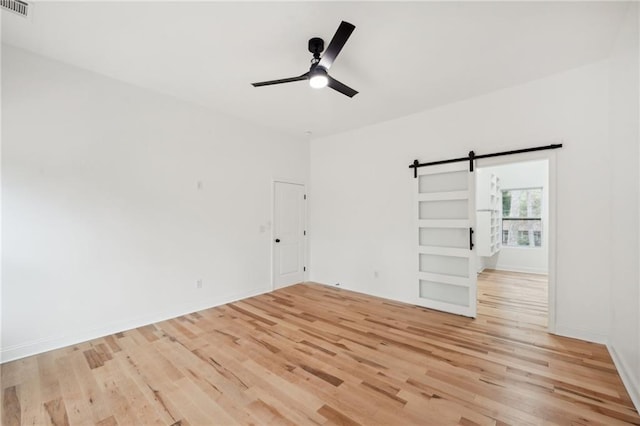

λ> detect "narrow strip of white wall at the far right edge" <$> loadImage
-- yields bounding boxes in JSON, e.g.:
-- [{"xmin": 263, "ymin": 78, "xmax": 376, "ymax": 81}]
[{"xmin": 609, "ymin": 3, "xmax": 640, "ymax": 409}]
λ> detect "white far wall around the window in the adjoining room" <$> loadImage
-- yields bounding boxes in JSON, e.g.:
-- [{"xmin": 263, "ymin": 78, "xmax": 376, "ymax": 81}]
[{"xmin": 478, "ymin": 157, "xmax": 549, "ymax": 274}]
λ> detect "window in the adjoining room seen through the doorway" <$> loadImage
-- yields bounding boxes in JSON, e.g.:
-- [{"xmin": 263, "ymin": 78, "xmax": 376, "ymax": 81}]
[{"xmin": 502, "ymin": 188, "xmax": 542, "ymax": 247}]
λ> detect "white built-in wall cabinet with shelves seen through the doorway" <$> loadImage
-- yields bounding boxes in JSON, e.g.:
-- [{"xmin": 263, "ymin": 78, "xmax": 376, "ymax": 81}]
[{"xmin": 476, "ymin": 169, "xmax": 502, "ymax": 257}]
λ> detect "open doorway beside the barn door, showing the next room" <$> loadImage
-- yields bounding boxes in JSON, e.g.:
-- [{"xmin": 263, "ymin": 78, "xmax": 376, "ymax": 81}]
[{"xmin": 476, "ymin": 152, "xmax": 555, "ymax": 332}]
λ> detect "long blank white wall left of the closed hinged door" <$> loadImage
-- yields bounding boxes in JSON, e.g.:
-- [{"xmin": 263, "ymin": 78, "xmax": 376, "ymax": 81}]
[{"xmin": 1, "ymin": 46, "xmax": 309, "ymax": 361}]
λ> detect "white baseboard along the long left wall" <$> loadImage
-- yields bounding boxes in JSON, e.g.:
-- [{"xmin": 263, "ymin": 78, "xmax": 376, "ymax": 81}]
[{"xmin": 0, "ymin": 286, "xmax": 271, "ymax": 364}]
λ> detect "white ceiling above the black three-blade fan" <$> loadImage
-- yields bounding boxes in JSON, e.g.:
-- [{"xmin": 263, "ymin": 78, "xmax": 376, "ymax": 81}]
[{"xmin": 2, "ymin": 1, "xmax": 628, "ymax": 137}]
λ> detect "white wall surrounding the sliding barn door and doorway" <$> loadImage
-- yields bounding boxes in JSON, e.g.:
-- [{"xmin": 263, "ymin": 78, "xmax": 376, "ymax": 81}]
[{"xmin": 310, "ymin": 62, "xmax": 611, "ymax": 342}]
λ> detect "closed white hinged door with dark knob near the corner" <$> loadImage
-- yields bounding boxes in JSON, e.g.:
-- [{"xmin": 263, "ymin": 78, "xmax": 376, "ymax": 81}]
[{"xmin": 273, "ymin": 182, "xmax": 306, "ymax": 288}]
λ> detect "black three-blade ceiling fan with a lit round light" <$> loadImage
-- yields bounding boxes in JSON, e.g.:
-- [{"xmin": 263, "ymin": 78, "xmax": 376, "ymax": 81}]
[{"xmin": 251, "ymin": 21, "xmax": 358, "ymax": 98}]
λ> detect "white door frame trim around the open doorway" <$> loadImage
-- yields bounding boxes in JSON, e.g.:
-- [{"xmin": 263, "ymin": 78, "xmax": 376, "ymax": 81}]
[{"xmin": 476, "ymin": 148, "xmax": 561, "ymax": 334}]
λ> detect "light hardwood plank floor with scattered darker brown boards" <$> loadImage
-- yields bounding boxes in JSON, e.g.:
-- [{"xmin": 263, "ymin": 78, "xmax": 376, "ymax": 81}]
[{"xmin": 1, "ymin": 271, "xmax": 640, "ymax": 426}]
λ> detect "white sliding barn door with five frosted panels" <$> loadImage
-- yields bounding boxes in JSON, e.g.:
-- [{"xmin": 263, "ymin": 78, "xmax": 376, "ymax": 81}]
[{"xmin": 415, "ymin": 162, "xmax": 477, "ymax": 317}]
